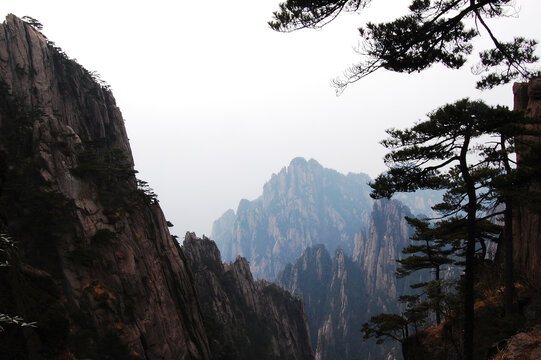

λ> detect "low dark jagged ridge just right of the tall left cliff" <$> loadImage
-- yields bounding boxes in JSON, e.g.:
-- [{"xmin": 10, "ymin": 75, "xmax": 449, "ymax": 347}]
[{"xmin": 182, "ymin": 233, "xmax": 313, "ymax": 360}]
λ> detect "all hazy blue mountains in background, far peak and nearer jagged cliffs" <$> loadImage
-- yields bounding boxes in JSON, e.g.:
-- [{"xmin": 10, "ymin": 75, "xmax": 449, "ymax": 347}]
[{"xmin": 212, "ymin": 158, "xmax": 441, "ymax": 360}]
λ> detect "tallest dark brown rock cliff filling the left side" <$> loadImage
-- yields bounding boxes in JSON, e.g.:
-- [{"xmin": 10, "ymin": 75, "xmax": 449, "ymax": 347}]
[{"xmin": 0, "ymin": 15, "xmax": 212, "ymax": 359}]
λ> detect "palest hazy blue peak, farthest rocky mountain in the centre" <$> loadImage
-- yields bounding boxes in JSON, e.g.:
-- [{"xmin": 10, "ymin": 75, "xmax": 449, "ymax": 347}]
[{"xmin": 212, "ymin": 158, "xmax": 372, "ymax": 280}]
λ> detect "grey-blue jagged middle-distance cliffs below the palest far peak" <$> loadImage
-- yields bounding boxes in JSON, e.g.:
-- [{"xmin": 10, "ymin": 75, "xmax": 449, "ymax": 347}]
[{"xmin": 277, "ymin": 200, "xmax": 416, "ymax": 360}]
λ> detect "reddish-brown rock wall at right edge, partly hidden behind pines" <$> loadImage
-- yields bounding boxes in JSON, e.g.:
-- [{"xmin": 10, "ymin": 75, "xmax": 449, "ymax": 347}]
[{"xmin": 513, "ymin": 79, "xmax": 541, "ymax": 287}]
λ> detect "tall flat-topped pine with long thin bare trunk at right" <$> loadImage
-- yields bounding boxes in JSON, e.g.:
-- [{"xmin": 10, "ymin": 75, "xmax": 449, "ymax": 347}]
[{"xmin": 371, "ymin": 99, "xmax": 534, "ymax": 359}]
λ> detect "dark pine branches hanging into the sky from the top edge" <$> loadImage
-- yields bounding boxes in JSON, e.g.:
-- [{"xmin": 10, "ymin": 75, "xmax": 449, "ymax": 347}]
[{"xmin": 269, "ymin": 0, "xmax": 539, "ymax": 93}]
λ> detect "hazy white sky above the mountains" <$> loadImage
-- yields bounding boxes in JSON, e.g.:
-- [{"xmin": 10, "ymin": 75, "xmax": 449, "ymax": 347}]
[{"xmin": 0, "ymin": 0, "xmax": 541, "ymax": 236}]
